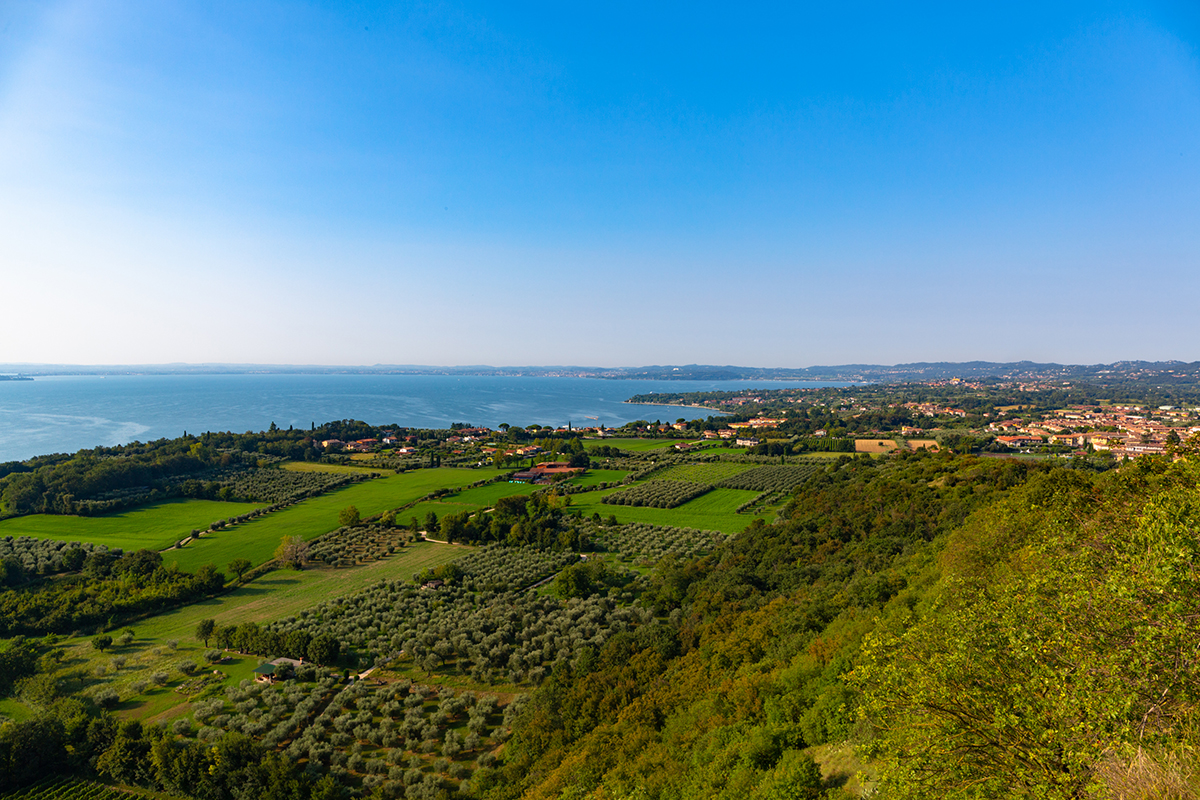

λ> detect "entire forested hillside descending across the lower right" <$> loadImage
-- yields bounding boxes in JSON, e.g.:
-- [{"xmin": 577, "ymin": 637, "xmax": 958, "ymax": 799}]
[{"xmin": 475, "ymin": 455, "xmax": 1200, "ymax": 799}]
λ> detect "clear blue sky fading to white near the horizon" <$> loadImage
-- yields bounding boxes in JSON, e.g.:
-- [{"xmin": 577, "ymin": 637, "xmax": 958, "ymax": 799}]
[{"xmin": 0, "ymin": 0, "xmax": 1200, "ymax": 367}]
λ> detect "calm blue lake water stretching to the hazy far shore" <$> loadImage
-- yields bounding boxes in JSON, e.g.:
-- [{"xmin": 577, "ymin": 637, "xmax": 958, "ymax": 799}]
[{"xmin": 0, "ymin": 374, "xmax": 848, "ymax": 462}]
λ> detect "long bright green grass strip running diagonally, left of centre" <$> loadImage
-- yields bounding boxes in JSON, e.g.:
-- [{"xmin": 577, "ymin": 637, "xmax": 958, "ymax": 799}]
[{"xmin": 163, "ymin": 467, "xmax": 482, "ymax": 571}]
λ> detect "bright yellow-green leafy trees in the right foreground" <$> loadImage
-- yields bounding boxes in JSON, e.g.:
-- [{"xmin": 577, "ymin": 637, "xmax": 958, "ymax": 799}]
[{"xmin": 854, "ymin": 462, "xmax": 1200, "ymax": 798}]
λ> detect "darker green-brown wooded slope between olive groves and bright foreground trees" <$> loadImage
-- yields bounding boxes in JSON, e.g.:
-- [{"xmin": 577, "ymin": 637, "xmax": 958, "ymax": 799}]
[{"xmin": 479, "ymin": 453, "xmax": 1042, "ymax": 799}]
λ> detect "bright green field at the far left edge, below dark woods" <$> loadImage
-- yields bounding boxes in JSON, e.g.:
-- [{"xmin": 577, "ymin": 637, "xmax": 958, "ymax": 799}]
[{"xmin": 0, "ymin": 500, "xmax": 264, "ymax": 551}]
